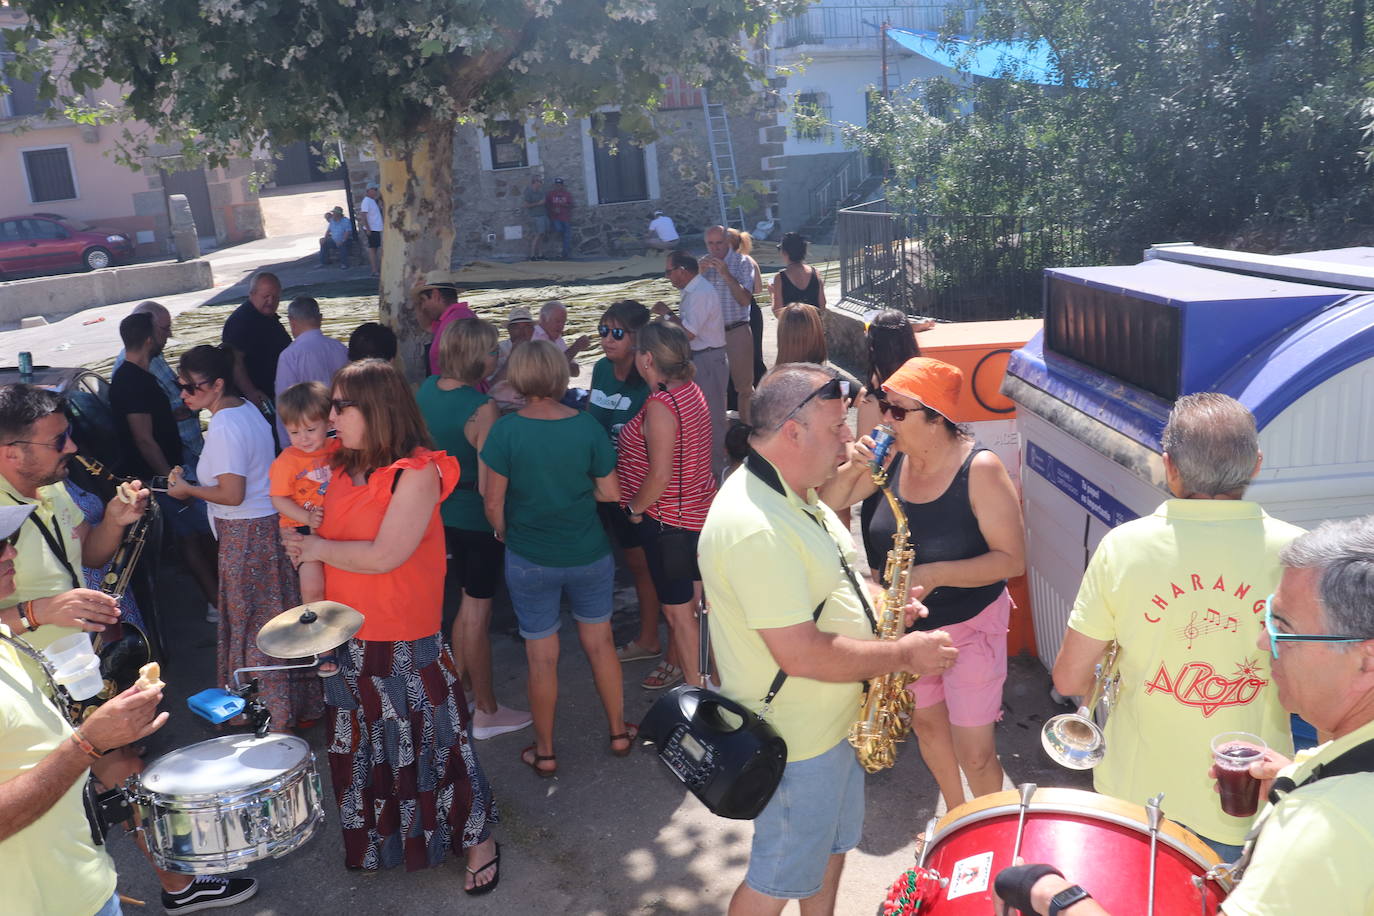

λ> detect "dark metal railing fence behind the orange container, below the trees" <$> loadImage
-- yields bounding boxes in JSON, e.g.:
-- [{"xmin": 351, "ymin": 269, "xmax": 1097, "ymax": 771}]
[{"xmin": 835, "ymin": 201, "xmax": 1110, "ymax": 321}]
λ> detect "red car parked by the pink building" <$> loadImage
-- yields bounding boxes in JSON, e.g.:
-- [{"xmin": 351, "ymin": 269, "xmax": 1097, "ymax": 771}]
[{"xmin": 0, "ymin": 213, "xmax": 133, "ymax": 277}]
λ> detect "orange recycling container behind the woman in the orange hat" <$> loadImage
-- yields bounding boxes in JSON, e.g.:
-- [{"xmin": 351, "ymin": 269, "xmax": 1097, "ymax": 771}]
[{"xmin": 916, "ymin": 319, "xmax": 1041, "ymax": 655}]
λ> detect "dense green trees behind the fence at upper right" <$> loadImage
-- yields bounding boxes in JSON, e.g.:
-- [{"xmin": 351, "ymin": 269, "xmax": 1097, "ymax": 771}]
[{"xmin": 853, "ymin": 0, "xmax": 1371, "ymax": 257}]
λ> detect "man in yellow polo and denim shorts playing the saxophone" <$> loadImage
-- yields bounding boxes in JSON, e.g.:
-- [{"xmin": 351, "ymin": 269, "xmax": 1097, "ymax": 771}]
[{"xmin": 699, "ymin": 363, "xmax": 958, "ymax": 916}]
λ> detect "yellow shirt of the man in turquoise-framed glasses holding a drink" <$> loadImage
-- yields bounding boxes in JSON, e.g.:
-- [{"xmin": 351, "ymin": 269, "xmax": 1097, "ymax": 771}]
[{"xmin": 1221, "ymin": 722, "xmax": 1374, "ymax": 916}]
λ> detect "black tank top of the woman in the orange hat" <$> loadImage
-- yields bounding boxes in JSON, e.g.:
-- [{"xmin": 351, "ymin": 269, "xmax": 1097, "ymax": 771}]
[{"xmin": 859, "ymin": 448, "xmax": 1007, "ymax": 630}]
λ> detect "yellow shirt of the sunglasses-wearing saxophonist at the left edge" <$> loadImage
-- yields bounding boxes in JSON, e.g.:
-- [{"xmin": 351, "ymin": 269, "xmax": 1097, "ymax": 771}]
[{"xmin": 0, "ymin": 477, "xmax": 85, "ymax": 650}]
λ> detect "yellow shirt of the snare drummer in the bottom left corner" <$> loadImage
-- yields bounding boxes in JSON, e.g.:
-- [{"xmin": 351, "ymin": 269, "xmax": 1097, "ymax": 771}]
[{"xmin": 0, "ymin": 626, "xmax": 115, "ymax": 916}]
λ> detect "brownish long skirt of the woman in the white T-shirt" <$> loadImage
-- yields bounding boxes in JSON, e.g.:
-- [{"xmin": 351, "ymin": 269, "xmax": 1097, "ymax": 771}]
[{"xmin": 214, "ymin": 515, "xmax": 324, "ymax": 729}]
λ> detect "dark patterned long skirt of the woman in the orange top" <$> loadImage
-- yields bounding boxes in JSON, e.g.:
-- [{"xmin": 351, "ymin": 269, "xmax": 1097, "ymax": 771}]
[{"xmin": 324, "ymin": 633, "xmax": 497, "ymax": 871}]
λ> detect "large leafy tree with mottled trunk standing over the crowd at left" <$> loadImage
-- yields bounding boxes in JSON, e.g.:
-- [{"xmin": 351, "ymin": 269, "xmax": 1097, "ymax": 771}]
[{"xmin": 7, "ymin": 0, "xmax": 805, "ymax": 373}]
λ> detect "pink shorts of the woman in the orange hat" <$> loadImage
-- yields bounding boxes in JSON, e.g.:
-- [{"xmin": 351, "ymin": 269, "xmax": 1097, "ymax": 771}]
[{"xmin": 907, "ymin": 589, "xmax": 1011, "ymax": 728}]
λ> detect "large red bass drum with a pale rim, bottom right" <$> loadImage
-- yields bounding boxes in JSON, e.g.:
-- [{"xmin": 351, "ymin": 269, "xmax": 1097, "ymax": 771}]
[{"xmin": 882, "ymin": 788, "xmax": 1231, "ymax": 916}]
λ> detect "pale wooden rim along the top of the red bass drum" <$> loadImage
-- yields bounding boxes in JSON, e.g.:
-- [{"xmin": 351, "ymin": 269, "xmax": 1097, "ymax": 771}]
[{"xmin": 919, "ymin": 787, "xmax": 1230, "ymax": 893}]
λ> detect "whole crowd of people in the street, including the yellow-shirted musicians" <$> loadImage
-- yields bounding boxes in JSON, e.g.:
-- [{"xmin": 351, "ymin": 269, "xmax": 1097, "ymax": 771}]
[{"xmin": 0, "ymin": 219, "xmax": 1374, "ymax": 916}]
